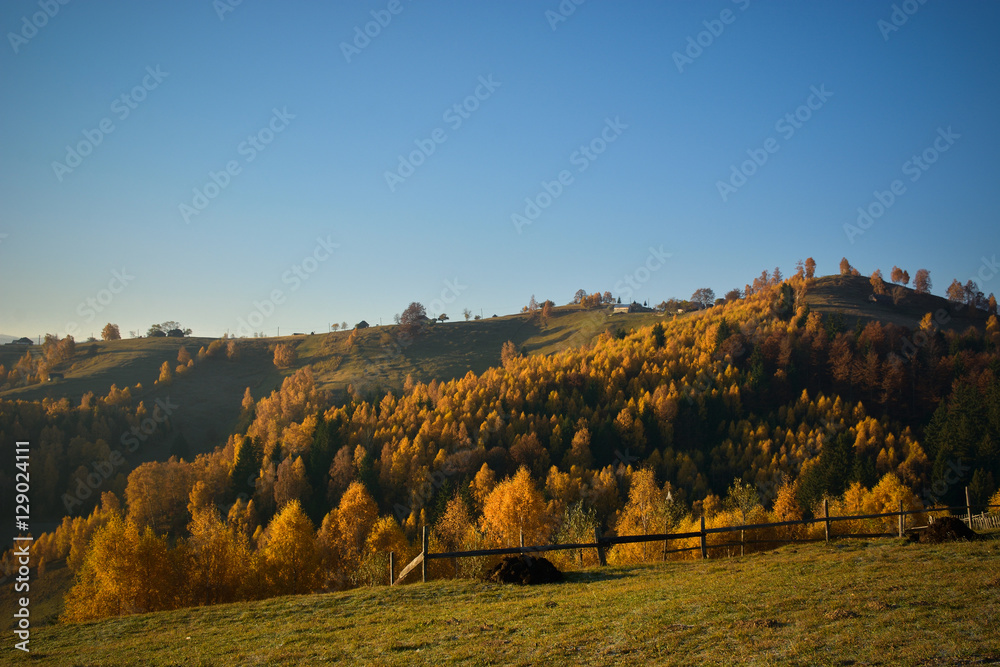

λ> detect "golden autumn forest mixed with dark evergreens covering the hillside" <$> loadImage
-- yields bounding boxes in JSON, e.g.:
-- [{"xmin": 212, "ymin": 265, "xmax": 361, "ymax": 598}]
[{"xmin": 0, "ymin": 267, "xmax": 1000, "ymax": 620}]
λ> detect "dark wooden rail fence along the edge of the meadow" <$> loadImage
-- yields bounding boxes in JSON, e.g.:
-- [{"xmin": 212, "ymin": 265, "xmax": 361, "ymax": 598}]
[{"xmin": 389, "ymin": 493, "xmax": 1000, "ymax": 585}]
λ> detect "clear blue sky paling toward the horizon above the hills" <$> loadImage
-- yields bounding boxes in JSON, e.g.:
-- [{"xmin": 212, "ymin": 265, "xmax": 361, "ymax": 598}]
[{"xmin": 0, "ymin": 0, "xmax": 1000, "ymax": 339}]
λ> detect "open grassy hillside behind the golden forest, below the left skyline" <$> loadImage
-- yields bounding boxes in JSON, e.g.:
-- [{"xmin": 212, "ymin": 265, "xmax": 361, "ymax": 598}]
[{"xmin": 0, "ymin": 306, "xmax": 660, "ymax": 460}]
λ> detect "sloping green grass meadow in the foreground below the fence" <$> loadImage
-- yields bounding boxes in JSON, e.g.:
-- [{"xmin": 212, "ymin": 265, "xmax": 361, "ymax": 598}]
[{"xmin": 23, "ymin": 538, "xmax": 1000, "ymax": 665}]
